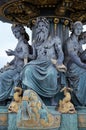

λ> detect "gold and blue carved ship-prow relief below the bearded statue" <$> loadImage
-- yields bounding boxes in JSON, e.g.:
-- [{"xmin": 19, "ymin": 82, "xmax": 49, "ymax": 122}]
[{"xmin": 17, "ymin": 90, "xmax": 61, "ymax": 130}]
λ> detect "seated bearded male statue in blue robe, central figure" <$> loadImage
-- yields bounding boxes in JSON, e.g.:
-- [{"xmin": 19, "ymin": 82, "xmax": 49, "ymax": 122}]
[{"xmin": 21, "ymin": 18, "xmax": 66, "ymax": 105}]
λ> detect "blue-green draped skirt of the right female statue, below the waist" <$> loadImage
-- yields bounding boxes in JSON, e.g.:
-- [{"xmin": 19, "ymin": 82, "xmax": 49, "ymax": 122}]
[{"xmin": 67, "ymin": 63, "xmax": 86, "ymax": 105}]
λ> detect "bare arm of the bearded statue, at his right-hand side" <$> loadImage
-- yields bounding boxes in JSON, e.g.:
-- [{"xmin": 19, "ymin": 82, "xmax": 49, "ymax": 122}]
[{"xmin": 55, "ymin": 38, "xmax": 64, "ymax": 64}]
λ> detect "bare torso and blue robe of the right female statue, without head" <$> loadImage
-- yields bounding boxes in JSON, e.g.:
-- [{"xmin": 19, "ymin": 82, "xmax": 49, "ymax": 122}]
[{"xmin": 64, "ymin": 36, "xmax": 86, "ymax": 105}]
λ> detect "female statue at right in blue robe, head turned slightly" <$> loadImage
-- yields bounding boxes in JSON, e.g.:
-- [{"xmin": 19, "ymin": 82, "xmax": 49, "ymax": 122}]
[{"xmin": 64, "ymin": 21, "xmax": 86, "ymax": 105}]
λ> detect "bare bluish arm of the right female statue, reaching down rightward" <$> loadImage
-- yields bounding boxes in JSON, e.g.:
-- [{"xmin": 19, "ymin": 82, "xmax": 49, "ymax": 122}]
[{"xmin": 67, "ymin": 41, "xmax": 86, "ymax": 69}]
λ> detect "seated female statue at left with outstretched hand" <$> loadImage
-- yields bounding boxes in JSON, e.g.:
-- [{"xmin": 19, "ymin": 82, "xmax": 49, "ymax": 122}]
[{"xmin": 0, "ymin": 25, "xmax": 29, "ymax": 101}]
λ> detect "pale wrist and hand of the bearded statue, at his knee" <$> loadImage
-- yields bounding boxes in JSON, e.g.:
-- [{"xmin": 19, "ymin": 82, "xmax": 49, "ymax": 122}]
[{"xmin": 51, "ymin": 59, "xmax": 67, "ymax": 72}]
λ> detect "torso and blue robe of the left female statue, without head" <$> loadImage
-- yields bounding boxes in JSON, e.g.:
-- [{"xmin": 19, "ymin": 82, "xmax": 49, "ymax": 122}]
[{"xmin": 0, "ymin": 39, "xmax": 28, "ymax": 101}]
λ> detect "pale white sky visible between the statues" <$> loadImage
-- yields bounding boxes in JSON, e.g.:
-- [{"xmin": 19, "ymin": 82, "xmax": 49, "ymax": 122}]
[{"xmin": 0, "ymin": 21, "xmax": 86, "ymax": 68}]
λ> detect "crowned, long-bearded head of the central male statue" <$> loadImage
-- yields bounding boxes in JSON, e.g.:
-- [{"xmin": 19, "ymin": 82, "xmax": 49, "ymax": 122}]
[{"xmin": 36, "ymin": 17, "xmax": 50, "ymax": 42}]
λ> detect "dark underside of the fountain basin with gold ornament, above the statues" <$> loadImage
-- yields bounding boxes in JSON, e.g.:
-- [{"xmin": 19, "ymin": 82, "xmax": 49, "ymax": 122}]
[{"xmin": 0, "ymin": 0, "xmax": 86, "ymax": 25}]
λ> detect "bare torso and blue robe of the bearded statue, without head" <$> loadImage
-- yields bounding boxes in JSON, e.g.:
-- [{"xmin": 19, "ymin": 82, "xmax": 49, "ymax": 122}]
[{"xmin": 21, "ymin": 39, "xmax": 63, "ymax": 97}]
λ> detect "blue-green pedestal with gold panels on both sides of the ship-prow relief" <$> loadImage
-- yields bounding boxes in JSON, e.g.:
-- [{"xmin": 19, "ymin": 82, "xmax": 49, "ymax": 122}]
[{"xmin": 0, "ymin": 106, "xmax": 86, "ymax": 130}]
